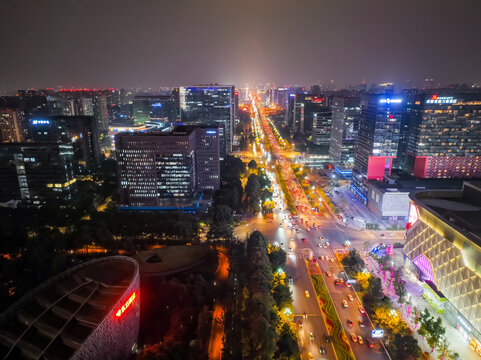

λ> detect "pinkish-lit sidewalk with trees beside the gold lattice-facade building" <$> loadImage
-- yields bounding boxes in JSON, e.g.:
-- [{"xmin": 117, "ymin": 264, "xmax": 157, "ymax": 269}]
[{"xmin": 363, "ymin": 251, "xmax": 479, "ymax": 360}]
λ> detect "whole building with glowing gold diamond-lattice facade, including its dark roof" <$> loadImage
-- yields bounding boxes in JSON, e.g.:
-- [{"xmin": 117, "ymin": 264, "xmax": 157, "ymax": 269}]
[{"xmin": 404, "ymin": 181, "xmax": 481, "ymax": 355}]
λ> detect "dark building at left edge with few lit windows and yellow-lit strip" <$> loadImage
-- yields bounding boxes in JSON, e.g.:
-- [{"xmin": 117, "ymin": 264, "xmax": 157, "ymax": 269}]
[{"xmin": 0, "ymin": 143, "xmax": 77, "ymax": 205}]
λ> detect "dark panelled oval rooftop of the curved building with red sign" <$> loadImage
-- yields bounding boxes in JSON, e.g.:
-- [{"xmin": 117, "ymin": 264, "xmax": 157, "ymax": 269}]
[{"xmin": 0, "ymin": 256, "xmax": 138, "ymax": 359}]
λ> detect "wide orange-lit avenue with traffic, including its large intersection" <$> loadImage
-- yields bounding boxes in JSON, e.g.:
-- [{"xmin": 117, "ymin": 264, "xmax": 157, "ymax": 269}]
[{"xmin": 235, "ymin": 97, "xmax": 389, "ymax": 360}]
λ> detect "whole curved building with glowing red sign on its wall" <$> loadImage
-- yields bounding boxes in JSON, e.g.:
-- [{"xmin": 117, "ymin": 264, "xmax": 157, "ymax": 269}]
[{"xmin": 0, "ymin": 256, "xmax": 140, "ymax": 360}]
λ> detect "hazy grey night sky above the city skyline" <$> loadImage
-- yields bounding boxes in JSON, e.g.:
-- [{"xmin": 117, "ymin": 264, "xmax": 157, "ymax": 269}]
[{"xmin": 0, "ymin": 0, "xmax": 481, "ymax": 90}]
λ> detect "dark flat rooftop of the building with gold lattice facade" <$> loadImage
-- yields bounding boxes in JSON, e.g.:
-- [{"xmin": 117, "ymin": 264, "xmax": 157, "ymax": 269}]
[{"xmin": 410, "ymin": 181, "xmax": 481, "ymax": 246}]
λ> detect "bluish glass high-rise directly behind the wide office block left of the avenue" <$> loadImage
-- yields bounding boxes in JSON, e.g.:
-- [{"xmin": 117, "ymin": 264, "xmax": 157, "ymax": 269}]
[{"xmin": 179, "ymin": 85, "xmax": 234, "ymax": 158}]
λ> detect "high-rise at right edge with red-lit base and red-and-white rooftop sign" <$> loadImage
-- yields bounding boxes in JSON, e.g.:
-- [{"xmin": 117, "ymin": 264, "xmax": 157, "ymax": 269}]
[{"xmin": 406, "ymin": 93, "xmax": 481, "ymax": 178}]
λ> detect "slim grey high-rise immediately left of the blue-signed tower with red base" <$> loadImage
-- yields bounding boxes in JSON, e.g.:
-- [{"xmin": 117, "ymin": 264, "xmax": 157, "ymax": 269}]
[{"xmin": 329, "ymin": 96, "xmax": 361, "ymax": 178}]
